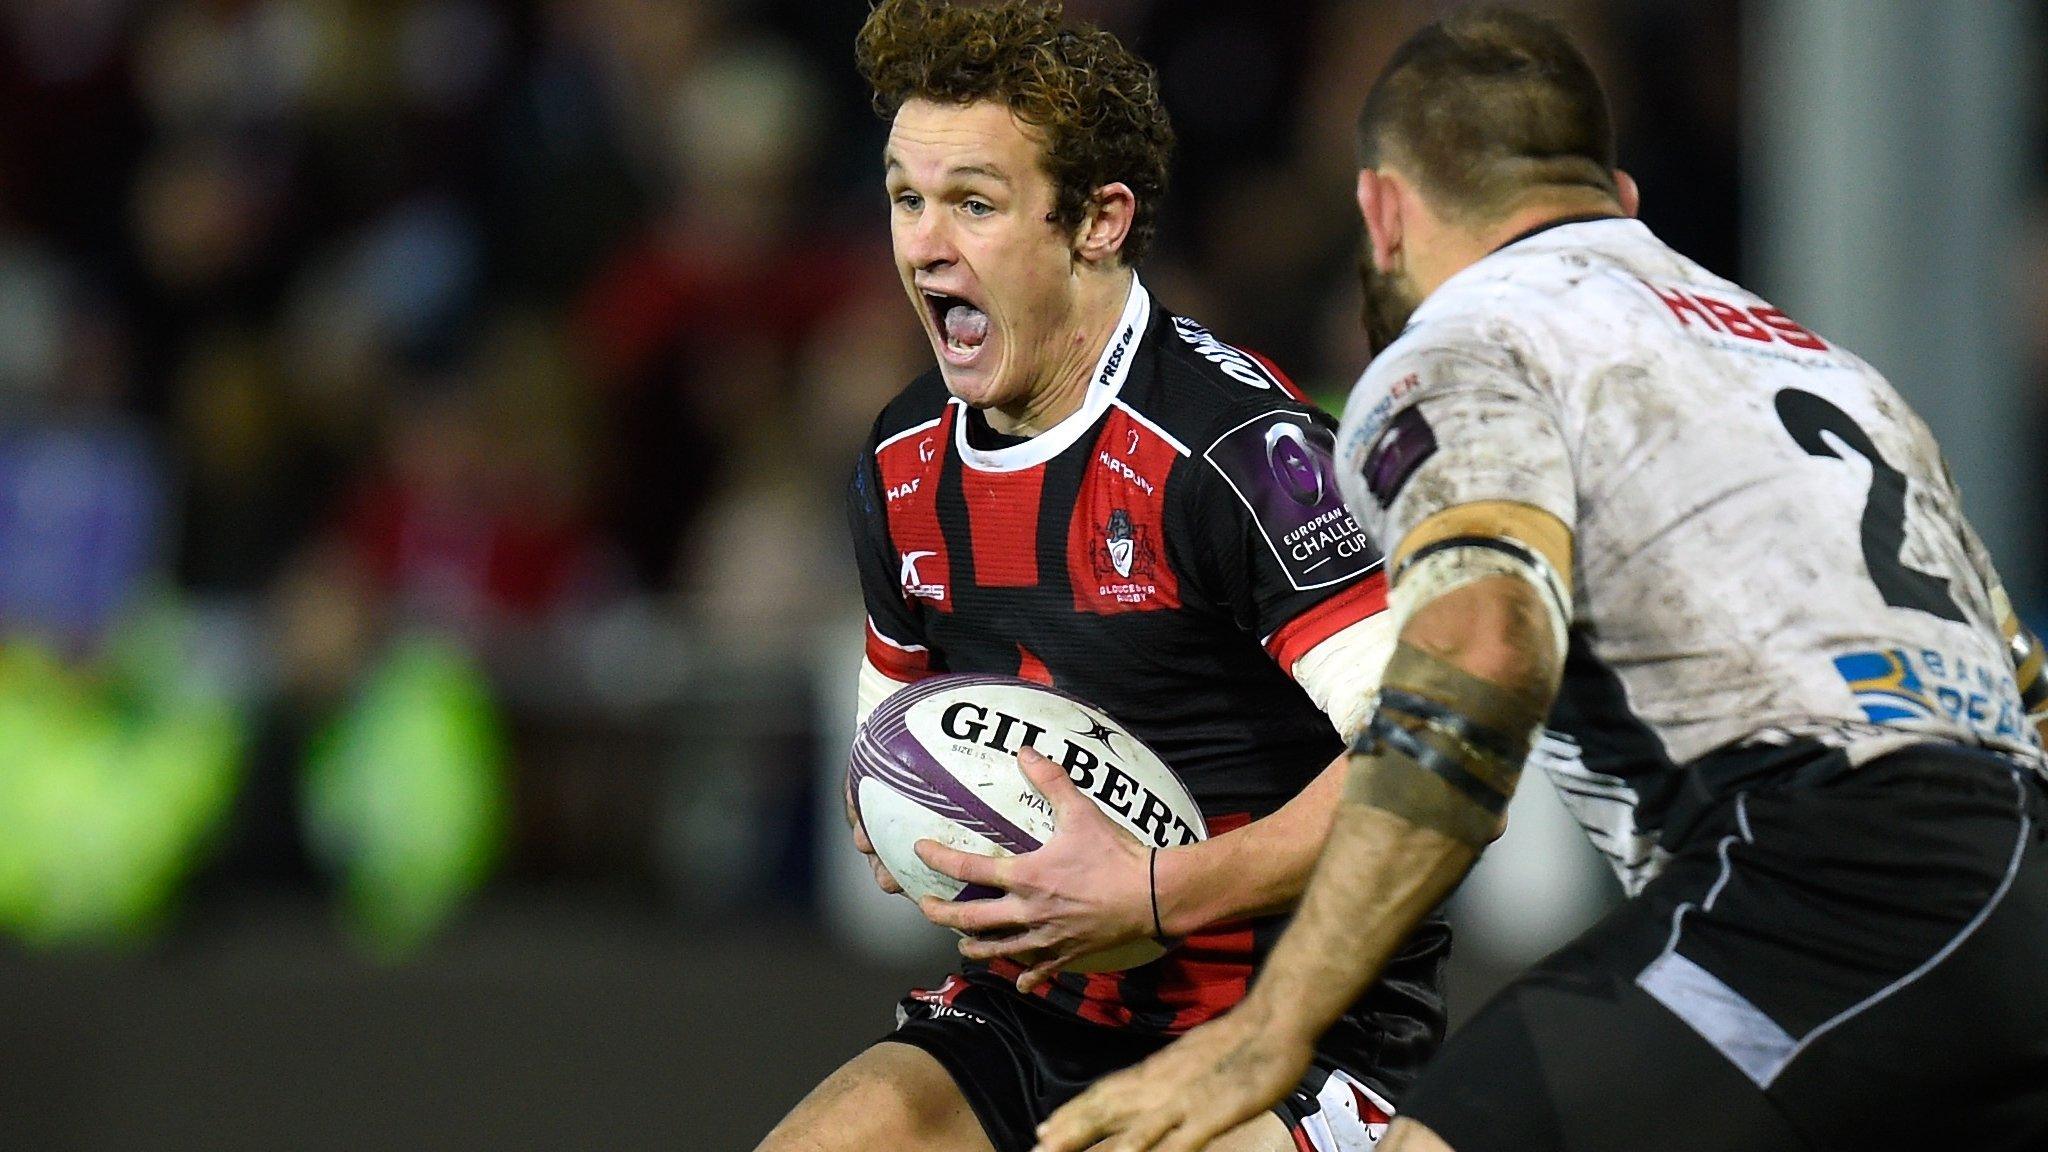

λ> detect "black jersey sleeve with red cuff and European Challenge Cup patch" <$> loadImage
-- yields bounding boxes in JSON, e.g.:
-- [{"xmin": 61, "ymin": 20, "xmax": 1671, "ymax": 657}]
[{"xmin": 1182, "ymin": 406, "xmax": 1386, "ymax": 674}]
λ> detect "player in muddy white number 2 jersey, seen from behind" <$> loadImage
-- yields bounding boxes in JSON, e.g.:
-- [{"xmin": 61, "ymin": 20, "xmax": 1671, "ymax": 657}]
[{"xmin": 1042, "ymin": 10, "xmax": 2048, "ymax": 1152}]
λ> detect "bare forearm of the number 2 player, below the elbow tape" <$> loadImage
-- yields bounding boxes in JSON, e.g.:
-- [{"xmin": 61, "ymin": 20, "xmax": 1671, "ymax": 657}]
[{"xmin": 1245, "ymin": 801, "xmax": 1479, "ymax": 1043}]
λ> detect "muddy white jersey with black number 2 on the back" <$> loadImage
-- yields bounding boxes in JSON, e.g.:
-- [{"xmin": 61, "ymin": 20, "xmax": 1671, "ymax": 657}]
[{"xmin": 1337, "ymin": 219, "xmax": 2042, "ymax": 881}]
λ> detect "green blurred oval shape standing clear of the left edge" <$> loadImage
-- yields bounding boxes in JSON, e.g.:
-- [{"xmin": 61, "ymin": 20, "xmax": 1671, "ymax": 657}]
[{"xmin": 301, "ymin": 637, "xmax": 508, "ymax": 959}]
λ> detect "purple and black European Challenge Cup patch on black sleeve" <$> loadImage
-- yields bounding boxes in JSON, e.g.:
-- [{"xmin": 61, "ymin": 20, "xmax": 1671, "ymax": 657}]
[{"xmin": 1202, "ymin": 412, "xmax": 1378, "ymax": 590}]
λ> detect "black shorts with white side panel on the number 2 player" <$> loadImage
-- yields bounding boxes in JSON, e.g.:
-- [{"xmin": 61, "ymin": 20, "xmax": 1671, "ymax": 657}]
[{"xmin": 1403, "ymin": 744, "xmax": 2048, "ymax": 1152}]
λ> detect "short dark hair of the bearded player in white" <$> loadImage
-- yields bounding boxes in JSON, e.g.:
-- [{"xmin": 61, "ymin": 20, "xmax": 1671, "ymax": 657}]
[{"xmin": 1358, "ymin": 6, "xmax": 1620, "ymax": 217}]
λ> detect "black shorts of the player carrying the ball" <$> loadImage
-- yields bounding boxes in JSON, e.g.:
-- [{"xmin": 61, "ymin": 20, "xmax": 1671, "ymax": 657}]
[{"xmin": 883, "ymin": 976, "xmax": 1393, "ymax": 1152}]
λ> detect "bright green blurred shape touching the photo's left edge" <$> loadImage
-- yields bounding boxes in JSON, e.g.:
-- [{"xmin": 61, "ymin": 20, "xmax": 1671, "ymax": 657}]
[{"xmin": 0, "ymin": 629, "xmax": 244, "ymax": 947}]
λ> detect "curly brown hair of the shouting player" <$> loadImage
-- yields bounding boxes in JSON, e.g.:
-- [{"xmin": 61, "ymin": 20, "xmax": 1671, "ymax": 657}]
[{"xmin": 854, "ymin": 0, "xmax": 1174, "ymax": 266}]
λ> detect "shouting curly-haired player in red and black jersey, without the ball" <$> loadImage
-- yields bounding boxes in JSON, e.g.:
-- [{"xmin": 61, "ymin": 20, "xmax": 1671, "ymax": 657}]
[{"xmin": 764, "ymin": 0, "xmax": 1448, "ymax": 1152}]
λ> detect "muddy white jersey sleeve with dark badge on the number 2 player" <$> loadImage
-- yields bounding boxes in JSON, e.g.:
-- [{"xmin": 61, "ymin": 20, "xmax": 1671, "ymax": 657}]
[{"xmin": 1337, "ymin": 309, "xmax": 1577, "ymax": 551}]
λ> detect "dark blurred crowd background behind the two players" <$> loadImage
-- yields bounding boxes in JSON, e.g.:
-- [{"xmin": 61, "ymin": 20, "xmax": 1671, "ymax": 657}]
[{"xmin": 0, "ymin": 0, "xmax": 2048, "ymax": 1148}]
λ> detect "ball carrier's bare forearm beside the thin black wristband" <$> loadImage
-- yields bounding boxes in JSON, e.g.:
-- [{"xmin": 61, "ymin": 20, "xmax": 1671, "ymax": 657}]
[{"xmin": 1157, "ymin": 756, "xmax": 1346, "ymax": 926}]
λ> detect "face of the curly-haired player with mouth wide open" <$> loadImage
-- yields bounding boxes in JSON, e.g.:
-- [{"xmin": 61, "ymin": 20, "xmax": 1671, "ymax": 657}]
[{"xmin": 883, "ymin": 100, "xmax": 1077, "ymax": 408}]
